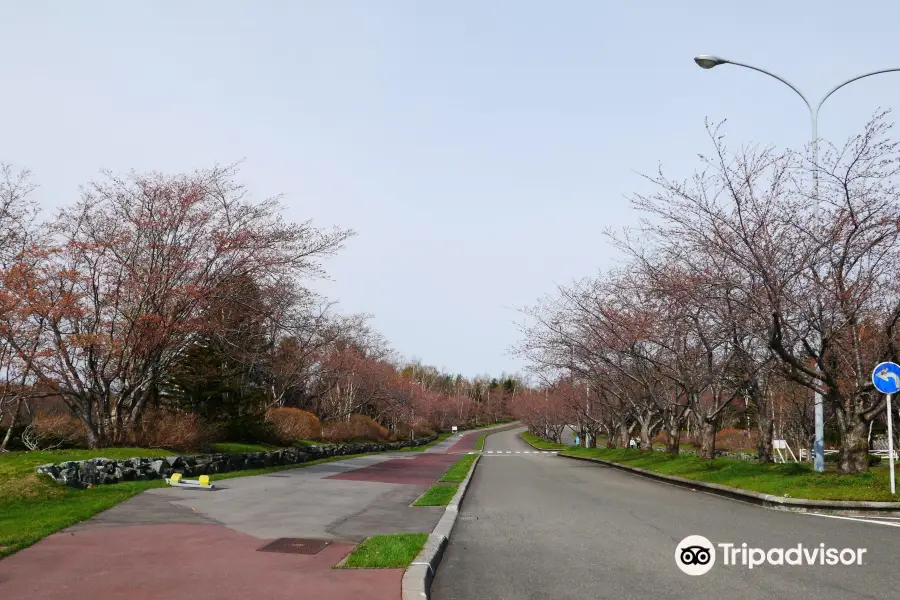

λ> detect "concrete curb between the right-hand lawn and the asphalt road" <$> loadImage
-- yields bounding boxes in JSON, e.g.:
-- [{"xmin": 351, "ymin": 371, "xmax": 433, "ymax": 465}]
[{"xmin": 557, "ymin": 454, "xmax": 900, "ymax": 515}]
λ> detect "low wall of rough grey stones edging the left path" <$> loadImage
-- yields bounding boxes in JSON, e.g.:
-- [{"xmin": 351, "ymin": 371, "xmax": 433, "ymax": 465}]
[{"xmin": 35, "ymin": 436, "xmax": 436, "ymax": 488}]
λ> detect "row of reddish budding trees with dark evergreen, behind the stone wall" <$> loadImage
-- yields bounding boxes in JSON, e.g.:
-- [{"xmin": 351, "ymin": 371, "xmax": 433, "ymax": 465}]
[{"xmin": 0, "ymin": 165, "xmax": 521, "ymax": 448}]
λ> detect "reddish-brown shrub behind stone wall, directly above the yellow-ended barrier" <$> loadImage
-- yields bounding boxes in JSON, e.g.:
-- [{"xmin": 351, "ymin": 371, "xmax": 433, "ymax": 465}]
[{"xmin": 131, "ymin": 409, "xmax": 219, "ymax": 451}]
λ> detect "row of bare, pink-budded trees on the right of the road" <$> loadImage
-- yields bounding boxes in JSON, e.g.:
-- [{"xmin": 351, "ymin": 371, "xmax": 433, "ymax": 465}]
[{"xmin": 516, "ymin": 112, "xmax": 900, "ymax": 473}]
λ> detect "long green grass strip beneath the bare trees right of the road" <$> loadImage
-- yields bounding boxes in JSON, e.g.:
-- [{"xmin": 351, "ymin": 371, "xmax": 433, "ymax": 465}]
[{"xmin": 563, "ymin": 448, "xmax": 897, "ymax": 502}]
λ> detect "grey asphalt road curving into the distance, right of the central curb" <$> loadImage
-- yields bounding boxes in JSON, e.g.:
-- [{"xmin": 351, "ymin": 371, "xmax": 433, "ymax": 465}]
[{"xmin": 432, "ymin": 429, "xmax": 900, "ymax": 600}]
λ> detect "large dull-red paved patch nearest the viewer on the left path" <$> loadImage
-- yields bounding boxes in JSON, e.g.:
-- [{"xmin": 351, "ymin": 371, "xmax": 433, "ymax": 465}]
[{"xmin": 0, "ymin": 524, "xmax": 403, "ymax": 600}]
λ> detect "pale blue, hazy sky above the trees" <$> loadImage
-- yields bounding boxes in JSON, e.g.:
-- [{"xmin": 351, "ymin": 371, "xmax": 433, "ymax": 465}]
[{"xmin": 0, "ymin": 0, "xmax": 900, "ymax": 376}]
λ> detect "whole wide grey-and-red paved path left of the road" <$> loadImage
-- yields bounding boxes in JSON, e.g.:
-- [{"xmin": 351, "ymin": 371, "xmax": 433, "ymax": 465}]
[{"xmin": 0, "ymin": 430, "xmax": 484, "ymax": 600}]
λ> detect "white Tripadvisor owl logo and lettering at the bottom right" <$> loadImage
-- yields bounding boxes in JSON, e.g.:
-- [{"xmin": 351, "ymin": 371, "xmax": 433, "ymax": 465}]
[{"xmin": 675, "ymin": 535, "xmax": 867, "ymax": 575}]
